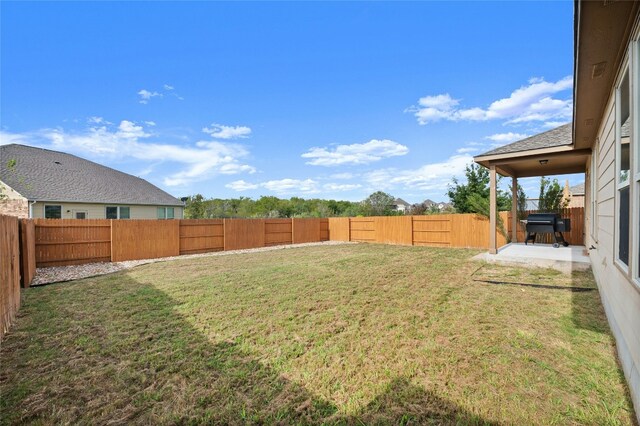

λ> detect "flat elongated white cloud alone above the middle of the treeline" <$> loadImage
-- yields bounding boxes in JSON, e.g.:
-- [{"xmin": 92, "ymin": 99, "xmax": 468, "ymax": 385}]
[{"xmin": 302, "ymin": 139, "xmax": 409, "ymax": 166}]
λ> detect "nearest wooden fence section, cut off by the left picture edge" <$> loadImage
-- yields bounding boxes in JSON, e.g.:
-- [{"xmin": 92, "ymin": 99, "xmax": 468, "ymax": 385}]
[{"xmin": 0, "ymin": 216, "xmax": 20, "ymax": 340}]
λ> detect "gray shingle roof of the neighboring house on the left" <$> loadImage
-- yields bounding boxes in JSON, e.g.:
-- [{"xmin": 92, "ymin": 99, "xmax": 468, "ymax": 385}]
[{"xmin": 0, "ymin": 144, "xmax": 182, "ymax": 206}]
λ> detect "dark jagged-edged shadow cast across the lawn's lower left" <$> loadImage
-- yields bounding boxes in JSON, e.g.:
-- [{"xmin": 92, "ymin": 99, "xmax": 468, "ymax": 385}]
[{"xmin": 0, "ymin": 274, "xmax": 496, "ymax": 424}]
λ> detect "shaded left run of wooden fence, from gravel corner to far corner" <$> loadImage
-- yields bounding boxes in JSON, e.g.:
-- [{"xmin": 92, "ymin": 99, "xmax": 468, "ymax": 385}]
[{"xmin": 25, "ymin": 219, "xmax": 329, "ymax": 267}]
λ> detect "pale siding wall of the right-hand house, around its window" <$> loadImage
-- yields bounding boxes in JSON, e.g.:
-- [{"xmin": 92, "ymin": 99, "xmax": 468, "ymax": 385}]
[{"xmin": 585, "ymin": 87, "xmax": 640, "ymax": 413}]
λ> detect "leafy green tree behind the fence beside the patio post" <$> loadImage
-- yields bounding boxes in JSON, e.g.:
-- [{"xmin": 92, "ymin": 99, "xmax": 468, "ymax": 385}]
[{"xmin": 447, "ymin": 164, "xmax": 511, "ymax": 213}]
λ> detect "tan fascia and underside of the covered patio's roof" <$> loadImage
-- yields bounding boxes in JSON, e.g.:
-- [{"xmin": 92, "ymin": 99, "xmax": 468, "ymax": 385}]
[{"xmin": 474, "ymin": 145, "xmax": 591, "ymax": 177}]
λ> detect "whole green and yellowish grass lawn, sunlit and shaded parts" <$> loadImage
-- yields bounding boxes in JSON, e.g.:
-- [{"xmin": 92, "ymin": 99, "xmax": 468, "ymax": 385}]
[{"xmin": 0, "ymin": 244, "xmax": 634, "ymax": 425}]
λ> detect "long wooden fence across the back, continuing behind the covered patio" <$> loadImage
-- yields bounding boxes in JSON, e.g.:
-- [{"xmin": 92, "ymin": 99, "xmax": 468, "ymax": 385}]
[{"xmin": 21, "ymin": 208, "xmax": 584, "ymax": 270}]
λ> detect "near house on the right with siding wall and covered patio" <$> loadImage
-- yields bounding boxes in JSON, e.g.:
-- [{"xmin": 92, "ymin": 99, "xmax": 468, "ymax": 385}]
[{"xmin": 475, "ymin": 1, "xmax": 640, "ymax": 420}]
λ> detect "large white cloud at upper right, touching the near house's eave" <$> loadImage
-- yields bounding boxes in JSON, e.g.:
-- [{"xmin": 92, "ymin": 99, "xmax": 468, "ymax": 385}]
[{"xmin": 407, "ymin": 76, "xmax": 573, "ymax": 125}]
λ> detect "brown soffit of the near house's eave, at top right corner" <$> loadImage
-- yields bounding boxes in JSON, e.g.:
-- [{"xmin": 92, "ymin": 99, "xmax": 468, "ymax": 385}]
[{"xmin": 573, "ymin": 0, "xmax": 640, "ymax": 149}]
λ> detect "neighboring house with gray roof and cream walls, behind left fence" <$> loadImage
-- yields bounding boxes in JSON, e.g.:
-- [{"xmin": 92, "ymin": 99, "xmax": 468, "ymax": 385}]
[{"xmin": 0, "ymin": 144, "xmax": 184, "ymax": 219}]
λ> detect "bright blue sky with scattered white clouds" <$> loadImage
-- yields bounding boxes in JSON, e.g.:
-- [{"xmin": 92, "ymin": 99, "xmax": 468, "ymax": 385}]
[{"xmin": 0, "ymin": 1, "xmax": 583, "ymax": 202}]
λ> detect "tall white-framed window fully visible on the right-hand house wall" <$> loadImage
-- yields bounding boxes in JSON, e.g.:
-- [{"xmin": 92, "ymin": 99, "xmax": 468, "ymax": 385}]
[{"xmin": 616, "ymin": 69, "xmax": 633, "ymax": 268}]
